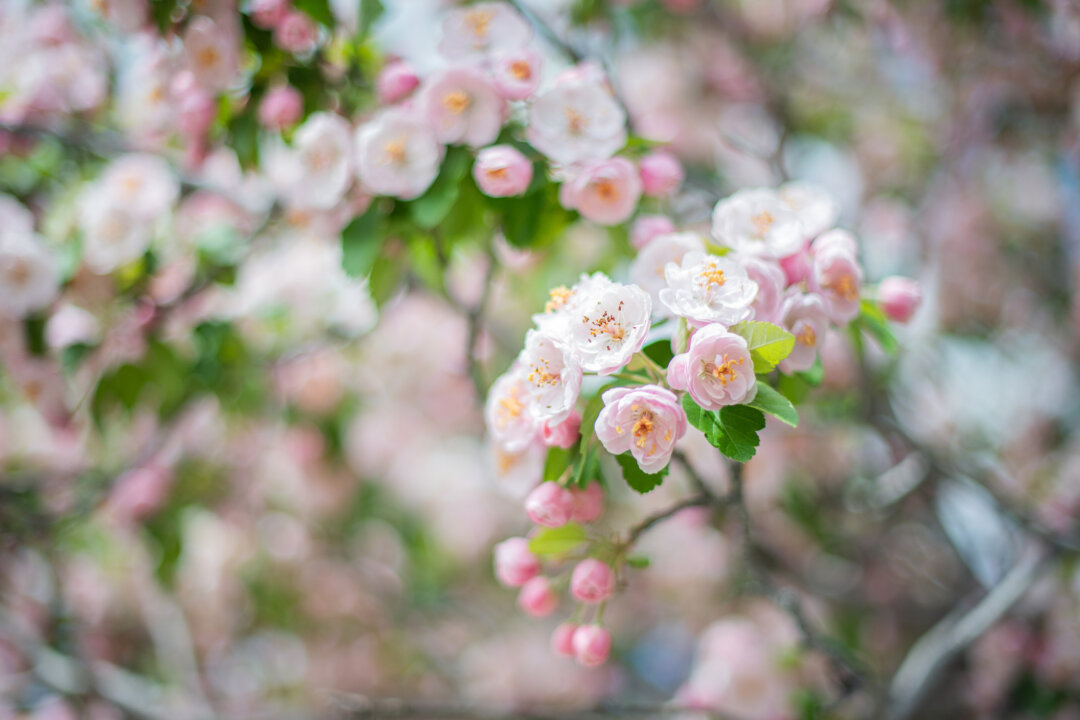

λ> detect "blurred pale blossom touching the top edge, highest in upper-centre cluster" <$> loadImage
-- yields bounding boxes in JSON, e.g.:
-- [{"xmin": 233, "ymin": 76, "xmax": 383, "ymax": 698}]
[{"xmin": 438, "ymin": 2, "xmax": 532, "ymax": 63}]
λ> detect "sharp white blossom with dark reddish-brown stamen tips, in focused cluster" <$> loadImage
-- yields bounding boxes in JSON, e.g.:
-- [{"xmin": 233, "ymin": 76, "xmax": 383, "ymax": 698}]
[{"xmin": 553, "ymin": 276, "xmax": 652, "ymax": 375}]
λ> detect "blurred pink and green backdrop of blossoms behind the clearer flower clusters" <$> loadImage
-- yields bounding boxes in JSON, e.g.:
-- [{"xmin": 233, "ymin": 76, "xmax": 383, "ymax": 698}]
[{"xmin": 0, "ymin": 0, "xmax": 1080, "ymax": 720}]
